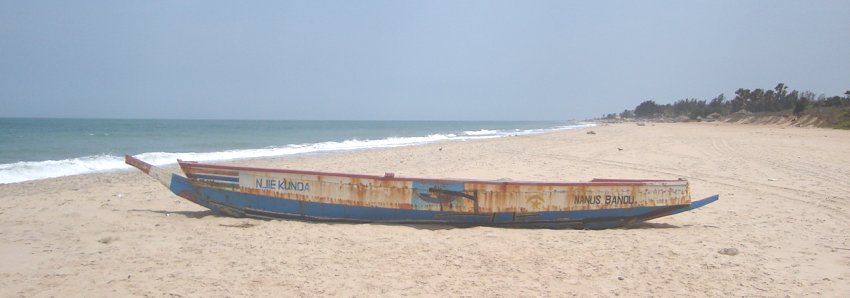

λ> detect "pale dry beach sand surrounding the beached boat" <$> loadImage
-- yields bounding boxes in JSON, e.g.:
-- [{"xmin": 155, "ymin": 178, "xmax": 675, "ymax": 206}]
[{"xmin": 0, "ymin": 123, "xmax": 850, "ymax": 297}]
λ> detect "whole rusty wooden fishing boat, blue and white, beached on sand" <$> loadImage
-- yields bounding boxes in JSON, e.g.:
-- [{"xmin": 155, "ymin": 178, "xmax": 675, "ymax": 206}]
[{"xmin": 125, "ymin": 155, "xmax": 719, "ymax": 229}]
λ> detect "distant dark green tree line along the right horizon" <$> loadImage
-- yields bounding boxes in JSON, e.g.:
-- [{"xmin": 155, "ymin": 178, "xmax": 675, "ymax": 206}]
[{"xmin": 604, "ymin": 83, "xmax": 850, "ymax": 119}]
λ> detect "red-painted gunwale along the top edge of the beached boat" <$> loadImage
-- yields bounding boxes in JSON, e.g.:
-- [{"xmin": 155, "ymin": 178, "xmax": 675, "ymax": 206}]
[{"xmin": 177, "ymin": 160, "xmax": 688, "ymax": 186}]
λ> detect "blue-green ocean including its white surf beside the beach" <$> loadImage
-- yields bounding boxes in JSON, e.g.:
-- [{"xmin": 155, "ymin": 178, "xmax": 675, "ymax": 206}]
[{"xmin": 0, "ymin": 118, "xmax": 593, "ymax": 183}]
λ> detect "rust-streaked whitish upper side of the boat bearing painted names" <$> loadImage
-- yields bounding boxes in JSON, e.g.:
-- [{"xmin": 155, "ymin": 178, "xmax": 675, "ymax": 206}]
[{"xmin": 184, "ymin": 167, "xmax": 691, "ymax": 213}]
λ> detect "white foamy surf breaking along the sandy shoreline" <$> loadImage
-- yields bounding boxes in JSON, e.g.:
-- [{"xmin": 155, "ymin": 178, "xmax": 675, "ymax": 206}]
[{"xmin": 0, "ymin": 123, "xmax": 594, "ymax": 184}]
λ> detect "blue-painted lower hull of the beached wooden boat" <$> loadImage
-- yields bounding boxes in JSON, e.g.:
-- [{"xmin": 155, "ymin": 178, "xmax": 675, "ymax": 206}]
[{"xmin": 162, "ymin": 175, "xmax": 718, "ymax": 229}]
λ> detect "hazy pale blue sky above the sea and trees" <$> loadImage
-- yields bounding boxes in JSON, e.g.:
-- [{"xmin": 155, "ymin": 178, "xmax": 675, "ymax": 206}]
[{"xmin": 0, "ymin": 0, "xmax": 850, "ymax": 120}]
